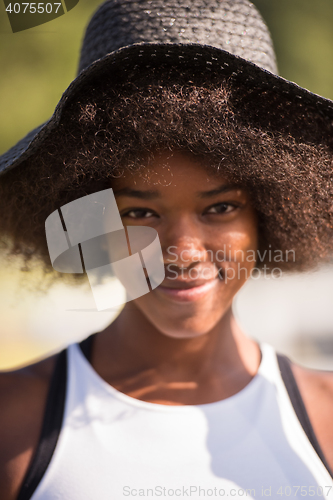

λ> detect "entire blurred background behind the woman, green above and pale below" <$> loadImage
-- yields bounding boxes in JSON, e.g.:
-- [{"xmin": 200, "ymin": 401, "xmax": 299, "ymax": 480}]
[{"xmin": 0, "ymin": 0, "xmax": 333, "ymax": 369}]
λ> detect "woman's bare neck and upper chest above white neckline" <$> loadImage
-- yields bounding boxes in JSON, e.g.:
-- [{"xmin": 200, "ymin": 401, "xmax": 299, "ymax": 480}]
[{"xmin": 92, "ymin": 304, "xmax": 260, "ymax": 405}]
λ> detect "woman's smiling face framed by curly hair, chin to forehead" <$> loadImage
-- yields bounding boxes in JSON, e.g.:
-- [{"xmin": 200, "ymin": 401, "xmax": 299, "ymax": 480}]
[{"xmin": 112, "ymin": 152, "xmax": 257, "ymax": 338}]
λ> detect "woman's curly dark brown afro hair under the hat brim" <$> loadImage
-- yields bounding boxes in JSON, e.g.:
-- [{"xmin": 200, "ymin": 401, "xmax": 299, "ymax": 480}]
[{"xmin": 0, "ymin": 67, "xmax": 333, "ymax": 279}]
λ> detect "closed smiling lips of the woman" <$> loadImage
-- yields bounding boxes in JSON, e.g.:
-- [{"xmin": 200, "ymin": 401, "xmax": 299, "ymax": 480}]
[{"xmin": 155, "ymin": 278, "xmax": 219, "ymax": 302}]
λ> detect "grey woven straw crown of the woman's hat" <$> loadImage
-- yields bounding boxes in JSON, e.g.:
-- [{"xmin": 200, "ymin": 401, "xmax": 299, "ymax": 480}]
[{"xmin": 79, "ymin": 0, "xmax": 277, "ymax": 74}]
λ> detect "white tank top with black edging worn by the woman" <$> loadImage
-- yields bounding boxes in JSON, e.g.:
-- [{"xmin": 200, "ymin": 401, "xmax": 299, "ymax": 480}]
[{"xmin": 25, "ymin": 344, "xmax": 333, "ymax": 500}]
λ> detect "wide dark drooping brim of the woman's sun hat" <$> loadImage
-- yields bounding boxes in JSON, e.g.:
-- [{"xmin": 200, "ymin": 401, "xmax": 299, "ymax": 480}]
[{"xmin": 0, "ymin": 43, "xmax": 333, "ymax": 175}]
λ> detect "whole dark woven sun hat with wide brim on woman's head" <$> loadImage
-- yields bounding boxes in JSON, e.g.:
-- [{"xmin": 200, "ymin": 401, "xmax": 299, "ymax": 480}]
[{"xmin": 0, "ymin": 0, "xmax": 333, "ymax": 174}]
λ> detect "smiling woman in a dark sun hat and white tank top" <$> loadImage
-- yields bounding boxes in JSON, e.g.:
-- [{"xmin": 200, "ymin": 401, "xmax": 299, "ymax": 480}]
[{"xmin": 0, "ymin": 0, "xmax": 333, "ymax": 500}]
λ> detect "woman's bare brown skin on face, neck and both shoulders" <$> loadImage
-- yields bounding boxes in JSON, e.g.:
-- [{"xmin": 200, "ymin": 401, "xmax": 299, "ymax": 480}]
[{"xmin": 0, "ymin": 153, "xmax": 333, "ymax": 500}]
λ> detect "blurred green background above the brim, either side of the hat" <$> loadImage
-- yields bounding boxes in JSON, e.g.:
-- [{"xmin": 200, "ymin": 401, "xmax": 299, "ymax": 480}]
[{"xmin": 0, "ymin": 0, "xmax": 333, "ymax": 154}]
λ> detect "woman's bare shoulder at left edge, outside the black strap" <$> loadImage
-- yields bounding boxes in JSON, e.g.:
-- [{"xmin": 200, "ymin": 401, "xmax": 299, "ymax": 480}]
[{"xmin": 0, "ymin": 356, "xmax": 56, "ymax": 500}]
